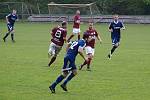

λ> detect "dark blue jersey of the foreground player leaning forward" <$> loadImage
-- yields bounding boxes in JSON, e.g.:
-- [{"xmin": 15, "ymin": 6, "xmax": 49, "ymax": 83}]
[{"xmin": 66, "ymin": 39, "xmax": 86, "ymax": 60}]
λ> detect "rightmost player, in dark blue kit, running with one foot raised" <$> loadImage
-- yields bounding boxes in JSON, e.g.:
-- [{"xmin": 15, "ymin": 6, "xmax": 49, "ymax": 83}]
[{"xmin": 108, "ymin": 15, "xmax": 125, "ymax": 59}]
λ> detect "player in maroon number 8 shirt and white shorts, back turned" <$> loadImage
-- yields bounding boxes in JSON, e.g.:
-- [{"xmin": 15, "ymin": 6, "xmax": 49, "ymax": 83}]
[{"xmin": 48, "ymin": 22, "xmax": 67, "ymax": 67}]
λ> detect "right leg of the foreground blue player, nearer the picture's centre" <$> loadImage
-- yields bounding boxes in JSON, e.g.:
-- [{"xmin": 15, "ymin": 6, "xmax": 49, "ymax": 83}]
[{"xmin": 61, "ymin": 62, "xmax": 77, "ymax": 91}]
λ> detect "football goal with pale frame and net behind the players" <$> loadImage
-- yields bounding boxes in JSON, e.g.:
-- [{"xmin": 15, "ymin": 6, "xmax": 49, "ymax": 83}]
[{"xmin": 48, "ymin": 2, "xmax": 100, "ymax": 22}]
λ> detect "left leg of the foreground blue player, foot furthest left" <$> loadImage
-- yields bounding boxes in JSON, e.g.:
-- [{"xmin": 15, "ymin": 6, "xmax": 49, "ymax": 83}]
[{"xmin": 49, "ymin": 57, "xmax": 69, "ymax": 93}]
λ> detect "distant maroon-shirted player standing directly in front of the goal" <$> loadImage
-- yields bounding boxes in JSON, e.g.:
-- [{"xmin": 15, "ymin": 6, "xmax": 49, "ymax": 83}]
[{"xmin": 67, "ymin": 10, "xmax": 80, "ymax": 42}]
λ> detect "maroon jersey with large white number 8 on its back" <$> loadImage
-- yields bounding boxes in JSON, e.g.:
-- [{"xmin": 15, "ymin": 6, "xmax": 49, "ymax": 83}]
[{"xmin": 51, "ymin": 27, "xmax": 67, "ymax": 46}]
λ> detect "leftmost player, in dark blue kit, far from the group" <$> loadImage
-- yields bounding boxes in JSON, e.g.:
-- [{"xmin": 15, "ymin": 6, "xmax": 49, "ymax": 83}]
[{"xmin": 3, "ymin": 10, "xmax": 17, "ymax": 42}]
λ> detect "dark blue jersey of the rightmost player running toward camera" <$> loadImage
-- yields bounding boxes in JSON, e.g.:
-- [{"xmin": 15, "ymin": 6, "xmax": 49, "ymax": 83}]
[{"xmin": 109, "ymin": 21, "xmax": 124, "ymax": 37}]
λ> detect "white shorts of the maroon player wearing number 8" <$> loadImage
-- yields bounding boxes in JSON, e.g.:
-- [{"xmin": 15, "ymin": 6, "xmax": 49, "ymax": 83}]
[{"xmin": 48, "ymin": 42, "xmax": 62, "ymax": 57}]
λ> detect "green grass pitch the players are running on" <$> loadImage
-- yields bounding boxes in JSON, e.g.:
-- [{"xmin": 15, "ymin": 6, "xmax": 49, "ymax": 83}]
[{"xmin": 0, "ymin": 22, "xmax": 150, "ymax": 100}]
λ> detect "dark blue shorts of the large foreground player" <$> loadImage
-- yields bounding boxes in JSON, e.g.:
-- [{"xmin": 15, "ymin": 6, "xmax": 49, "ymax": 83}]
[{"xmin": 62, "ymin": 56, "xmax": 77, "ymax": 71}]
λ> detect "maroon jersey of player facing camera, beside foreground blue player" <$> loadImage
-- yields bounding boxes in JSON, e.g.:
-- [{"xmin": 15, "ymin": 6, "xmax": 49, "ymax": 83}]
[{"xmin": 84, "ymin": 29, "xmax": 98, "ymax": 48}]
